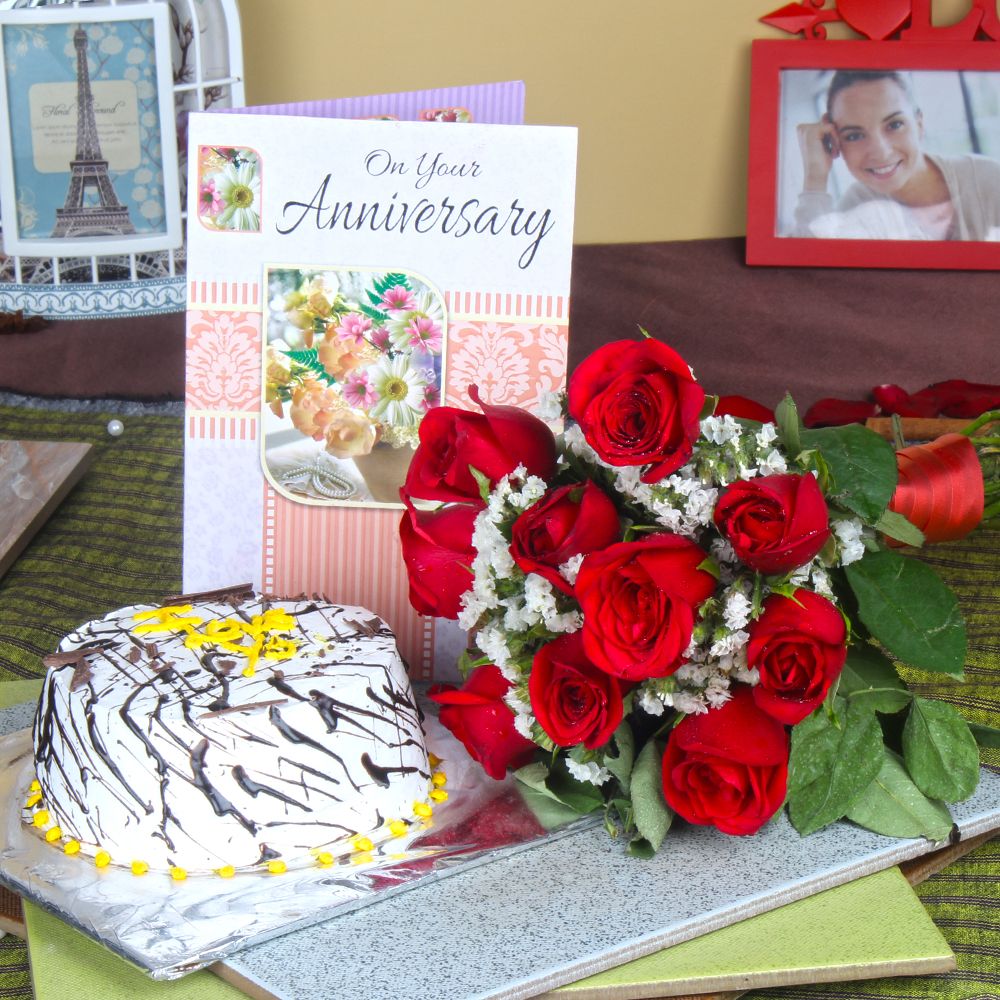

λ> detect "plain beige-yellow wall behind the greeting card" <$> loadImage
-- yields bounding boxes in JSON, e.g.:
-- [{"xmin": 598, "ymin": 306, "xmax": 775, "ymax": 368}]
[{"xmin": 239, "ymin": 0, "xmax": 969, "ymax": 243}]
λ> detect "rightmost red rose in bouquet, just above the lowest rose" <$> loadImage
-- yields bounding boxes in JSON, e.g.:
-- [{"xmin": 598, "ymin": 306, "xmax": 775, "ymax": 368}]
[{"xmin": 747, "ymin": 590, "xmax": 847, "ymax": 726}]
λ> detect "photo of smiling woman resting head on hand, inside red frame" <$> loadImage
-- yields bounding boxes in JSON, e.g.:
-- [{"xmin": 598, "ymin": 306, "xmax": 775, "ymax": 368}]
[{"xmin": 777, "ymin": 69, "xmax": 1000, "ymax": 242}]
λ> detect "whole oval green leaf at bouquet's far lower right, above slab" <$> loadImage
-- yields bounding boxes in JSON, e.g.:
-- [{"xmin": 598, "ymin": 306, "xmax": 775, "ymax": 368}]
[{"xmin": 903, "ymin": 698, "xmax": 979, "ymax": 802}]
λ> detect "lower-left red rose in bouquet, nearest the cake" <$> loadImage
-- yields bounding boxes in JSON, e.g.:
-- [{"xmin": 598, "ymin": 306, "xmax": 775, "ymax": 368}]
[{"xmin": 427, "ymin": 663, "xmax": 537, "ymax": 781}]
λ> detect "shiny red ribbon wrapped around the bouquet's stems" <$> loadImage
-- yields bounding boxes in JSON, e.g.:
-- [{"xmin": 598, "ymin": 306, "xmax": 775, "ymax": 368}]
[{"xmin": 889, "ymin": 434, "xmax": 985, "ymax": 542}]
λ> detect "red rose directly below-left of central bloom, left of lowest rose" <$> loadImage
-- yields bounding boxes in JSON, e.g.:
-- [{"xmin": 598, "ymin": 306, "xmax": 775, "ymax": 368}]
[{"xmin": 528, "ymin": 632, "xmax": 622, "ymax": 750}]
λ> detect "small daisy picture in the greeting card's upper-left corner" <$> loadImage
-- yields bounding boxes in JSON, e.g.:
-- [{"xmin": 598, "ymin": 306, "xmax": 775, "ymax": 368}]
[{"xmin": 198, "ymin": 146, "xmax": 261, "ymax": 233}]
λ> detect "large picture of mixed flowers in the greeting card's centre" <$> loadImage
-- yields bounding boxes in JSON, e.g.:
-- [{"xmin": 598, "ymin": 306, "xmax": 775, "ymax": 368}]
[{"xmin": 262, "ymin": 267, "xmax": 447, "ymax": 504}]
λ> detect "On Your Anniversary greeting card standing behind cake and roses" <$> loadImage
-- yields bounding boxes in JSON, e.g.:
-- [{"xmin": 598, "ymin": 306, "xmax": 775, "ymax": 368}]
[{"xmin": 184, "ymin": 88, "xmax": 576, "ymax": 679}]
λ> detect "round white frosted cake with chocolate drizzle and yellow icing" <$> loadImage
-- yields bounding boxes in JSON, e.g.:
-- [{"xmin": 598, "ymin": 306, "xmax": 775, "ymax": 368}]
[{"xmin": 34, "ymin": 599, "xmax": 430, "ymax": 873}]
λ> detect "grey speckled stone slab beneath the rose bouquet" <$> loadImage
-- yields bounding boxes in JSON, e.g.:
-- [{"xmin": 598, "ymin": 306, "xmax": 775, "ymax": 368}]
[{"xmin": 226, "ymin": 771, "xmax": 1000, "ymax": 1000}]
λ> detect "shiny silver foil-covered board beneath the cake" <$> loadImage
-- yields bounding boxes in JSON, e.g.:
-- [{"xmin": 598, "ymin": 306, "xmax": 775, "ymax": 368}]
[{"xmin": 0, "ymin": 704, "xmax": 599, "ymax": 979}]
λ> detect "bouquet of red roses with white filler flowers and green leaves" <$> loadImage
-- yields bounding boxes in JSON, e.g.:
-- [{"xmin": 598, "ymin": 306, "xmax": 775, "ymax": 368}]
[{"xmin": 400, "ymin": 338, "xmax": 997, "ymax": 855}]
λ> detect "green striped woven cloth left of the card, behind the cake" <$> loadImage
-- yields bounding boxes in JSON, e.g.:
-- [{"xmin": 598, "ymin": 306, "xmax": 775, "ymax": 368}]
[{"xmin": 0, "ymin": 407, "xmax": 183, "ymax": 681}]
